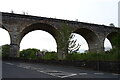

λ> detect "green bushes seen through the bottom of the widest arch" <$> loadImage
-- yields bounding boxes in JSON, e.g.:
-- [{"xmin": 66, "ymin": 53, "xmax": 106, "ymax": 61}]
[{"xmin": 20, "ymin": 48, "xmax": 57, "ymax": 60}]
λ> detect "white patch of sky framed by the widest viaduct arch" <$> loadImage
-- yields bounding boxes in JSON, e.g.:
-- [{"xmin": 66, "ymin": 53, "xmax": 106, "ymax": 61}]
[{"xmin": 20, "ymin": 30, "xmax": 57, "ymax": 52}]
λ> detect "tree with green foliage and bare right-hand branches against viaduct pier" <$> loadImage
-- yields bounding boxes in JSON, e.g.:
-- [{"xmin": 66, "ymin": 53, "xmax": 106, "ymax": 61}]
[{"xmin": 58, "ymin": 23, "xmax": 80, "ymax": 55}]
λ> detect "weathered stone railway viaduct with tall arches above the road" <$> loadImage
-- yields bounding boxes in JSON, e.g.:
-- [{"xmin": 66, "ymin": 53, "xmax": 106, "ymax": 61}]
[{"xmin": 0, "ymin": 12, "xmax": 120, "ymax": 57}]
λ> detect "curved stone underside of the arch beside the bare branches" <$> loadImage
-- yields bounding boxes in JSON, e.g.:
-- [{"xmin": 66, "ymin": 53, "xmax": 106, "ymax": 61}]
[{"xmin": 74, "ymin": 28, "xmax": 103, "ymax": 52}]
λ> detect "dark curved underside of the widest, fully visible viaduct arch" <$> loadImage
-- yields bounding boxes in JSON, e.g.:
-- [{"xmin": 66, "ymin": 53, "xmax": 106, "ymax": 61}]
[{"xmin": 19, "ymin": 23, "xmax": 60, "ymax": 52}]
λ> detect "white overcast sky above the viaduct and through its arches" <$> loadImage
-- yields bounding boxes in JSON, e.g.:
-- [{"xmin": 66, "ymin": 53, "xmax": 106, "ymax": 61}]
[{"xmin": 0, "ymin": 0, "xmax": 119, "ymax": 51}]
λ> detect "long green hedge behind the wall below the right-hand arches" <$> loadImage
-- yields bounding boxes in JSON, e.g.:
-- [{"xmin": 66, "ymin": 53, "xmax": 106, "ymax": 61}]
[{"xmin": 66, "ymin": 50, "xmax": 120, "ymax": 61}]
